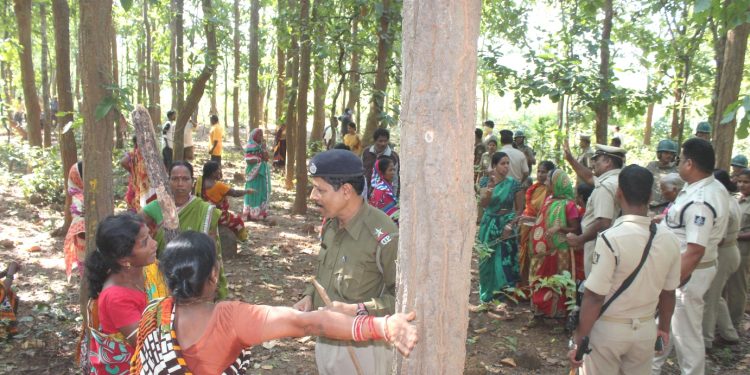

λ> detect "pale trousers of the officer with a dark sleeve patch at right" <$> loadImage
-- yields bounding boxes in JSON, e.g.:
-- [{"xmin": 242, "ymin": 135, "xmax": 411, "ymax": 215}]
[{"xmin": 651, "ymin": 266, "xmax": 716, "ymax": 375}]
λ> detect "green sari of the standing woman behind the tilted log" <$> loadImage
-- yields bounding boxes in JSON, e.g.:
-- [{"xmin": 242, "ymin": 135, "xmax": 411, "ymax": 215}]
[{"xmin": 143, "ymin": 197, "xmax": 227, "ymax": 299}]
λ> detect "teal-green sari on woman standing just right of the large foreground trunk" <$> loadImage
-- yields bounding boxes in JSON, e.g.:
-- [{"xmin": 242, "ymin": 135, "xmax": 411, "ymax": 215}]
[{"xmin": 478, "ymin": 176, "xmax": 521, "ymax": 302}]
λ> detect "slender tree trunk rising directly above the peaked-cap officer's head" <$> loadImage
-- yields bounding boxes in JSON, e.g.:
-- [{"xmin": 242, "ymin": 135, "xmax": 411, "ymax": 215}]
[{"xmin": 594, "ymin": 0, "xmax": 613, "ymax": 145}]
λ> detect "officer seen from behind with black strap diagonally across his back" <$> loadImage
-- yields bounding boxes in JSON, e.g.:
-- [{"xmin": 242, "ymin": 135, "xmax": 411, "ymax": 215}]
[{"xmin": 568, "ymin": 165, "xmax": 680, "ymax": 374}]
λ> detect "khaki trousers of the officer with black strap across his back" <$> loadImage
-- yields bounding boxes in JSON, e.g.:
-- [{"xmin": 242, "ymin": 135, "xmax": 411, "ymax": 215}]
[{"xmin": 582, "ymin": 318, "xmax": 656, "ymax": 375}]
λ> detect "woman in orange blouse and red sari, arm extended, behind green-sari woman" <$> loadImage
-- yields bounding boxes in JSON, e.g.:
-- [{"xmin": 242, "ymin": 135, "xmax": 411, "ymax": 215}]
[{"xmin": 195, "ymin": 160, "xmax": 255, "ymax": 242}]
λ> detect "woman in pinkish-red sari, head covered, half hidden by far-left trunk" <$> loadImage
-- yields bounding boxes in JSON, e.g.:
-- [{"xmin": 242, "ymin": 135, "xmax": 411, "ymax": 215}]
[{"xmin": 63, "ymin": 161, "xmax": 86, "ymax": 281}]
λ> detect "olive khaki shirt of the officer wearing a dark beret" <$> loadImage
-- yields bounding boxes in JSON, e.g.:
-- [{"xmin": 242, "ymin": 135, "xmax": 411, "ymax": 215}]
[{"xmin": 304, "ymin": 202, "xmax": 398, "ymax": 316}]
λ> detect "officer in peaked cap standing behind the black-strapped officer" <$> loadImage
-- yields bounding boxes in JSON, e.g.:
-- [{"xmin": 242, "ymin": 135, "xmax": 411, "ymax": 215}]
[{"xmin": 567, "ymin": 145, "xmax": 627, "ymax": 276}]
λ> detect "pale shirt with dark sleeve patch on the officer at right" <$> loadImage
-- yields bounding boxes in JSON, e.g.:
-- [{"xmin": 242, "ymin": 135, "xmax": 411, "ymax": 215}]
[{"xmin": 661, "ymin": 175, "xmax": 729, "ymax": 263}]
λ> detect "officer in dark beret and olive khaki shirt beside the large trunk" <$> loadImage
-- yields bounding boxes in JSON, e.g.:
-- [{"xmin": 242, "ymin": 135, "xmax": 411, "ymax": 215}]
[{"xmin": 294, "ymin": 149, "xmax": 398, "ymax": 374}]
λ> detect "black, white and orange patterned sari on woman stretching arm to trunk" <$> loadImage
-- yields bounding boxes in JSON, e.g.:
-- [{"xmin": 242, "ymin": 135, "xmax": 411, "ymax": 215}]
[{"xmin": 130, "ymin": 297, "xmax": 251, "ymax": 375}]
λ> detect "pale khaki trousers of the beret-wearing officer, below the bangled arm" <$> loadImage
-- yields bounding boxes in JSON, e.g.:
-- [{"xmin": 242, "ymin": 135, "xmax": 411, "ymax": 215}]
[{"xmin": 315, "ymin": 338, "xmax": 393, "ymax": 375}]
